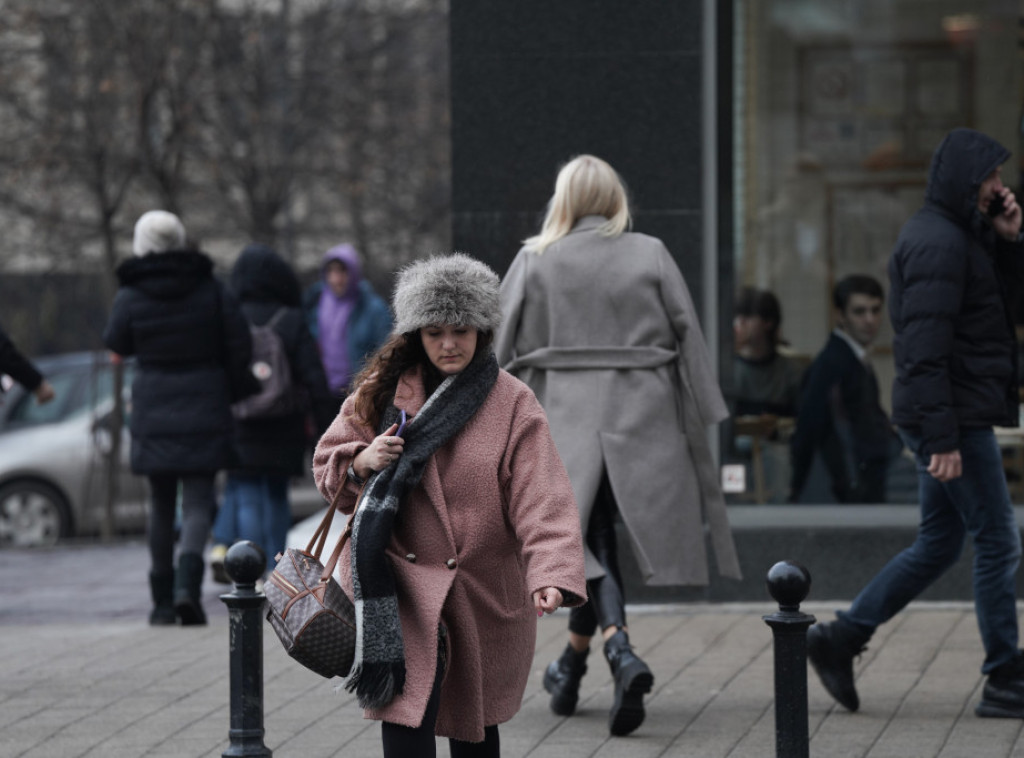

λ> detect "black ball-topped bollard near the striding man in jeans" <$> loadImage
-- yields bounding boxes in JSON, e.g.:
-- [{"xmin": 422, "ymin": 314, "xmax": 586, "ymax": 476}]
[{"xmin": 763, "ymin": 560, "xmax": 814, "ymax": 758}]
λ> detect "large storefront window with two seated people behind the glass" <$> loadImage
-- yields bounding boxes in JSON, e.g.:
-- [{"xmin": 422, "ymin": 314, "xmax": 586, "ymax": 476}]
[{"xmin": 723, "ymin": 0, "xmax": 1024, "ymax": 504}]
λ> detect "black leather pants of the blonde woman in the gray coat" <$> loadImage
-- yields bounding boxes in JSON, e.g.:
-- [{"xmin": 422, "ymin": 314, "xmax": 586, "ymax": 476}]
[{"xmin": 569, "ymin": 471, "xmax": 626, "ymax": 637}]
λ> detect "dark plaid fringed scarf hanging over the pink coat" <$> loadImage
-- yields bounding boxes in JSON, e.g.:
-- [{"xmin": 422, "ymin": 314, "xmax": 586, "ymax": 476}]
[{"xmin": 345, "ymin": 350, "xmax": 498, "ymax": 708}]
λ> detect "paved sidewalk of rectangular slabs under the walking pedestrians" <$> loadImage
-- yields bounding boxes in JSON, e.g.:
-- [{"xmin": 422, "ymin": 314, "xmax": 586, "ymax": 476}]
[{"xmin": 0, "ymin": 543, "xmax": 1024, "ymax": 758}]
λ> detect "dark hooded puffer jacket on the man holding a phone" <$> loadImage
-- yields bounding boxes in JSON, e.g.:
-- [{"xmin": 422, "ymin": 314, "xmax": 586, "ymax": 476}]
[{"xmin": 889, "ymin": 129, "xmax": 1024, "ymax": 455}]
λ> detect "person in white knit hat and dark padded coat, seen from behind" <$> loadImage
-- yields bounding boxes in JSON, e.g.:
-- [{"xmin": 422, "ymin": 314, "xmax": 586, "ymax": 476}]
[{"xmin": 103, "ymin": 211, "xmax": 260, "ymax": 626}]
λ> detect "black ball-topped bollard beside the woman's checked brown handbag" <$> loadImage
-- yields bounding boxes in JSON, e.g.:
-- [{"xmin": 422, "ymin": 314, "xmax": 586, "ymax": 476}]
[{"xmin": 220, "ymin": 540, "xmax": 273, "ymax": 758}]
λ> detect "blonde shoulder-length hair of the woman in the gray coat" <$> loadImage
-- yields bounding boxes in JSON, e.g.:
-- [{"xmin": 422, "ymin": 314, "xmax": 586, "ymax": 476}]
[{"xmin": 523, "ymin": 155, "xmax": 633, "ymax": 255}]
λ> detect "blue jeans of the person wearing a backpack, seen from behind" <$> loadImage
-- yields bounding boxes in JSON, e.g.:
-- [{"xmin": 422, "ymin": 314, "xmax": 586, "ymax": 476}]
[{"xmin": 213, "ymin": 473, "xmax": 292, "ymax": 571}]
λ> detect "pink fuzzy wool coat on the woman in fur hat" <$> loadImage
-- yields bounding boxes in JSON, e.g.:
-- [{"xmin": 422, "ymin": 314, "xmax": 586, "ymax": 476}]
[{"xmin": 313, "ymin": 370, "xmax": 587, "ymax": 742}]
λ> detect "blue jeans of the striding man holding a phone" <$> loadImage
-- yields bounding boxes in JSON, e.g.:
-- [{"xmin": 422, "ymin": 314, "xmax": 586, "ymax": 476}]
[{"xmin": 838, "ymin": 427, "xmax": 1021, "ymax": 674}]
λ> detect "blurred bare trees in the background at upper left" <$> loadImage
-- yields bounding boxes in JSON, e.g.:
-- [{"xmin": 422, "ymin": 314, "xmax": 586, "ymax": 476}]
[{"xmin": 0, "ymin": 0, "xmax": 450, "ymax": 540}]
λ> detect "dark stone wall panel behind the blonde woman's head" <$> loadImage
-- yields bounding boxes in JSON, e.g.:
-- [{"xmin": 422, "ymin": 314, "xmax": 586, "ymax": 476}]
[{"xmin": 451, "ymin": 0, "xmax": 702, "ymax": 312}]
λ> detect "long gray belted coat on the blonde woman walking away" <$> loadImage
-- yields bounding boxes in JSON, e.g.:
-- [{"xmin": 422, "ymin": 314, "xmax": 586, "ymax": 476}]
[{"xmin": 495, "ymin": 216, "xmax": 740, "ymax": 586}]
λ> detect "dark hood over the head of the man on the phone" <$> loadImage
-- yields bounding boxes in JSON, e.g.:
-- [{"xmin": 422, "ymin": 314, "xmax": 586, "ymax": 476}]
[{"xmin": 925, "ymin": 129, "xmax": 1010, "ymax": 224}]
